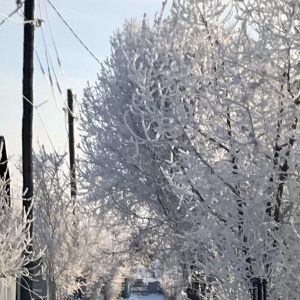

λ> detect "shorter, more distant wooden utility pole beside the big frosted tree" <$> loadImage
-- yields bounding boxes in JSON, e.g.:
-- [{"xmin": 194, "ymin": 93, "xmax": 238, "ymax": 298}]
[{"xmin": 68, "ymin": 89, "xmax": 77, "ymax": 202}]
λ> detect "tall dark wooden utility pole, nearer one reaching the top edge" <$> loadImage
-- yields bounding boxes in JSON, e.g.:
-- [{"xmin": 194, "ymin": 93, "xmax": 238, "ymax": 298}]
[{"xmin": 20, "ymin": 0, "xmax": 34, "ymax": 300}]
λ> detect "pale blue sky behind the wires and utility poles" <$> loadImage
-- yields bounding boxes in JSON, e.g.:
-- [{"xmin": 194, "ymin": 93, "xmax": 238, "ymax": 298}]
[{"xmin": 0, "ymin": 0, "xmax": 169, "ymax": 180}]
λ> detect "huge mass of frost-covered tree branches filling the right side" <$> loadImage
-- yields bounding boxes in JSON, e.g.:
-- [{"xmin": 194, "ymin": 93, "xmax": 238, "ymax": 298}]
[{"xmin": 81, "ymin": 0, "xmax": 300, "ymax": 299}]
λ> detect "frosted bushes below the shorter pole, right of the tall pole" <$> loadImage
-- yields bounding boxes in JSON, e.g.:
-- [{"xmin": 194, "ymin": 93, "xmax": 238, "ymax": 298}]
[{"xmin": 34, "ymin": 147, "xmax": 125, "ymax": 299}]
